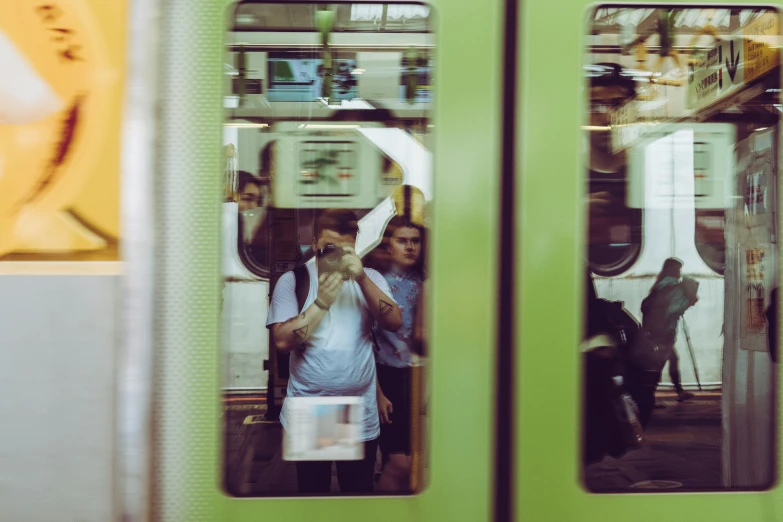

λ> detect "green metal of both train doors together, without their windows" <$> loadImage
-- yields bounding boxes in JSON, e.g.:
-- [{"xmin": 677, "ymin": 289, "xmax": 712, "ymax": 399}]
[{"xmin": 138, "ymin": 0, "xmax": 783, "ymax": 521}]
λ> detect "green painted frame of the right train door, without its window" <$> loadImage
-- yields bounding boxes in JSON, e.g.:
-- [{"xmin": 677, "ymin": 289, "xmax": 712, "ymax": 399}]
[{"xmin": 515, "ymin": 0, "xmax": 783, "ymax": 522}]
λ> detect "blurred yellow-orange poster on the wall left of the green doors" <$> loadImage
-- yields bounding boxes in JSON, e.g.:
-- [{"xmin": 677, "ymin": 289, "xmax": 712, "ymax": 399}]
[{"xmin": 0, "ymin": 0, "xmax": 127, "ymax": 261}]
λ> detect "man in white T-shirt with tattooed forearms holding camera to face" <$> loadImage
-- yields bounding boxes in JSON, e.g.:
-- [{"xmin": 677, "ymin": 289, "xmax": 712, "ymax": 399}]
[{"xmin": 267, "ymin": 209, "xmax": 402, "ymax": 494}]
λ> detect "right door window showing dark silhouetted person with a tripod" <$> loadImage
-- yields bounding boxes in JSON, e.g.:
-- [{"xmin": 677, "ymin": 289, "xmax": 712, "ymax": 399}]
[{"xmin": 581, "ymin": 6, "xmax": 783, "ymax": 493}]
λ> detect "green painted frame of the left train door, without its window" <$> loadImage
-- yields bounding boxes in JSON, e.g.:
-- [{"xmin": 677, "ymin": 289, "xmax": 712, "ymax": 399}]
[{"xmin": 155, "ymin": 0, "xmax": 503, "ymax": 522}]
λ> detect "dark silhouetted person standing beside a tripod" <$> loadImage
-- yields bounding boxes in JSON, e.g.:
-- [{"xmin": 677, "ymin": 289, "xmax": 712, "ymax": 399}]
[{"xmin": 642, "ymin": 258, "xmax": 699, "ymax": 402}]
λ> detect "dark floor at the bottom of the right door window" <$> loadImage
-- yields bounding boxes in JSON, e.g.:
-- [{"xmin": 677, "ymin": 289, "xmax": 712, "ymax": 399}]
[{"xmin": 584, "ymin": 392, "xmax": 723, "ymax": 492}]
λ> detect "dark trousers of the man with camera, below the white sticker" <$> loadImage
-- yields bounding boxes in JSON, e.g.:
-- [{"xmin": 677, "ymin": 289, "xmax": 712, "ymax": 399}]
[{"xmin": 296, "ymin": 439, "xmax": 378, "ymax": 495}]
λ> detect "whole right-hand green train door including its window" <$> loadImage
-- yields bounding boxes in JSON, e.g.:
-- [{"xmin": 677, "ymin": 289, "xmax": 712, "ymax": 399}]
[{"xmin": 515, "ymin": 2, "xmax": 781, "ymax": 521}]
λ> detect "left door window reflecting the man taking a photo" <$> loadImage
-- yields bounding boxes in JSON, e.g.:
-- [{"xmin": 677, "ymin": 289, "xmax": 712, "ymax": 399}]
[{"xmin": 222, "ymin": 1, "xmax": 435, "ymax": 497}]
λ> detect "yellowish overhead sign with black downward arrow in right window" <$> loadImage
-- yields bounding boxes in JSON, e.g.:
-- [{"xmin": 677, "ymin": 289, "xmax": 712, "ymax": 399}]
[{"xmin": 688, "ymin": 37, "xmax": 745, "ymax": 110}]
